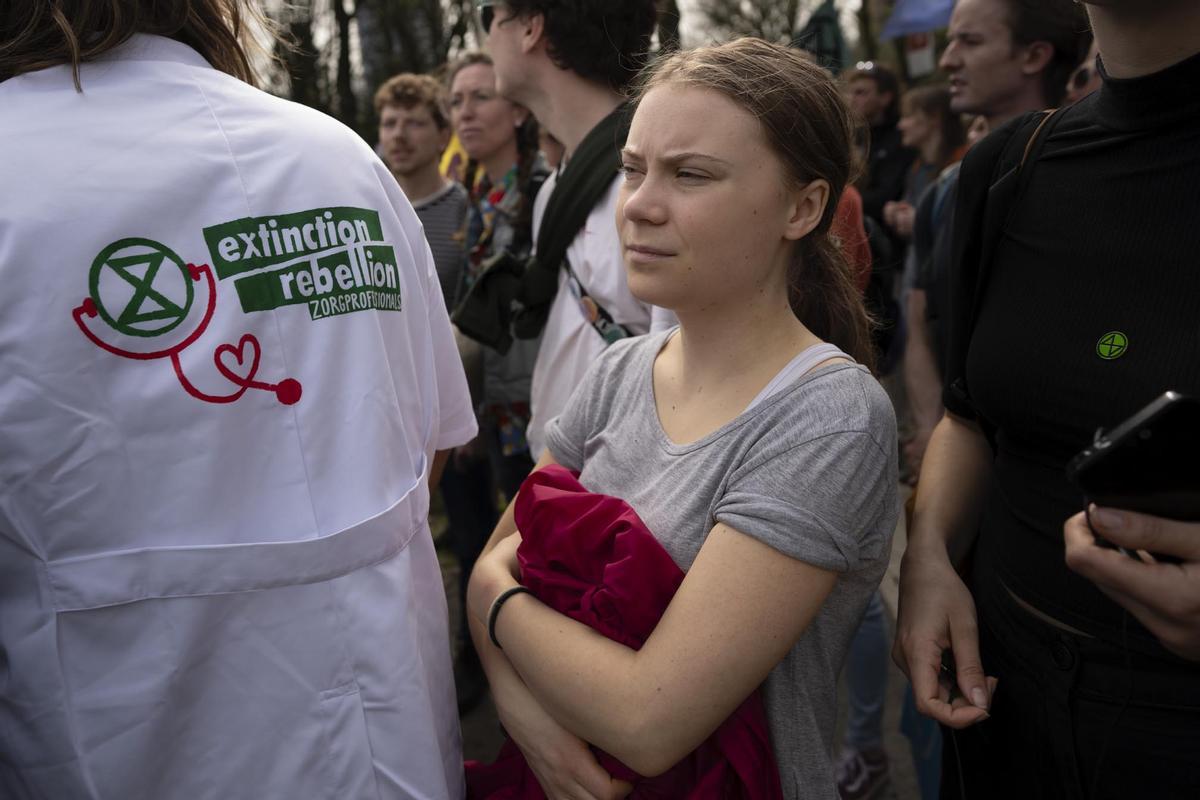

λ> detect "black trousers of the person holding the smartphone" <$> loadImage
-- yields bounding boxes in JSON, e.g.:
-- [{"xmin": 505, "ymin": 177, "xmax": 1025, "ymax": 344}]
[{"xmin": 942, "ymin": 582, "xmax": 1200, "ymax": 800}]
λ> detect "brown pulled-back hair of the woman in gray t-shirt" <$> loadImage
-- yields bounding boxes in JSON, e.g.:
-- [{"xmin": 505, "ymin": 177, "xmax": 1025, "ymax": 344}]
[{"xmin": 635, "ymin": 38, "xmax": 875, "ymax": 368}]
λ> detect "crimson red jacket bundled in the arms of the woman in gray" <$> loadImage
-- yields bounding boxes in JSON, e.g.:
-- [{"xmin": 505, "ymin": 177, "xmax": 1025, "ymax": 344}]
[{"xmin": 467, "ymin": 465, "xmax": 782, "ymax": 800}]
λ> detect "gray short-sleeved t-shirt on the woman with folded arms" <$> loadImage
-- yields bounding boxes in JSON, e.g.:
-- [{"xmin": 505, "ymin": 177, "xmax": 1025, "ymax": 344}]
[{"xmin": 546, "ymin": 331, "xmax": 899, "ymax": 800}]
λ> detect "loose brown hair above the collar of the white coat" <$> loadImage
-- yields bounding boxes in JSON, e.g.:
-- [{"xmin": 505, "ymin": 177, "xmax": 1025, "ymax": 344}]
[{"xmin": 0, "ymin": 0, "xmax": 275, "ymax": 90}]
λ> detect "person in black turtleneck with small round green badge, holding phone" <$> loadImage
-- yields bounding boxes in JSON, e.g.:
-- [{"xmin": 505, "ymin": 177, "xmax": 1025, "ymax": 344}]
[{"xmin": 896, "ymin": 0, "xmax": 1200, "ymax": 800}]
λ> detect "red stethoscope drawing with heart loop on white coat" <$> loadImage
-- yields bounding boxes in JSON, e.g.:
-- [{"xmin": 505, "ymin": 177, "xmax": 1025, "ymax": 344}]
[{"xmin": 72, "ymin": 264, "xmax": 301, "ymax": 405}]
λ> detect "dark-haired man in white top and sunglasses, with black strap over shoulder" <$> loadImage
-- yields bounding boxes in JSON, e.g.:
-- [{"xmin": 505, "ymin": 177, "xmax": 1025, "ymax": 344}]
[{"xmin": 480, "ymin": 0, "xmax": 673, "ymax": 458}]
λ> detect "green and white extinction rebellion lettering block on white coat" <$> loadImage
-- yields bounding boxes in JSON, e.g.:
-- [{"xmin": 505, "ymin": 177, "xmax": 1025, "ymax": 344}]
[{"xmin": 204, "ymin": 206, "xmax": 401, "ymax": 319}]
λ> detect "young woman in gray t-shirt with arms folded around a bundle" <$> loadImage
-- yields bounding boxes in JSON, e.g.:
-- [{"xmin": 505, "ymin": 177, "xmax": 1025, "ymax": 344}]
[{"xmin": 468, "ymin": 38, "xmax": 898, "ymax": 800}]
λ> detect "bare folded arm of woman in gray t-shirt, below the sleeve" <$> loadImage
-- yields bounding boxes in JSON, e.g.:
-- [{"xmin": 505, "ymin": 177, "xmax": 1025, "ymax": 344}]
[{"xmin": 469, "ymin": 524, "xmax": 836, "ymax": 776}]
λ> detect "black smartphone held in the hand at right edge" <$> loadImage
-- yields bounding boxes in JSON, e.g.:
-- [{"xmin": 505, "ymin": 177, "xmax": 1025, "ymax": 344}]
[{"xmin": 1067, "ymin": 392, "xmax": 1200, "ymax": 560}]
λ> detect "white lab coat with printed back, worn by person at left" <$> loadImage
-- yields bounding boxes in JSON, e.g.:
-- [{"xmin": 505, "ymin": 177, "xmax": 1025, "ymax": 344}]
[{"xmin": 0, "ymin": 36, "xmax": 475, "ymax": 800}]
